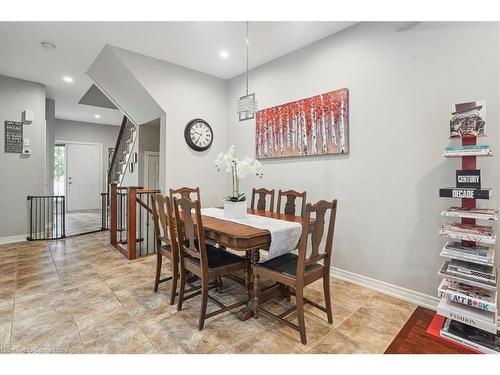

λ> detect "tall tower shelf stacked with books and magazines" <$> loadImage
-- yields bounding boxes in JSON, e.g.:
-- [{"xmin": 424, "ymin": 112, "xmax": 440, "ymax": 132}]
[{"xmin": 428, "ymin": 107, "xmax": 500, "ymax": 353}]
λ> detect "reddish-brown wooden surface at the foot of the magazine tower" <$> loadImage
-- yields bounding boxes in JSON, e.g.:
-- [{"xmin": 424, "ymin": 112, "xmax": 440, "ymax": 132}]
[{"xmin": 385, "ymin": 306, "xmax": 469, "ymax": 354}]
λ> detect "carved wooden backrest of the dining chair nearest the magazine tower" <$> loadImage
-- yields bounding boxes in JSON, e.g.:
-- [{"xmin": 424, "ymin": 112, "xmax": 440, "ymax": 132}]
[{"xmin": 297, "ymin": 203, "xmax": 337, "ymax": 278}]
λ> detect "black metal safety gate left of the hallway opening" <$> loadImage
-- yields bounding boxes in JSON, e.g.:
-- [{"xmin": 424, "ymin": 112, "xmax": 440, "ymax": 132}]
[{"xmin": 26, "ymin": 195, "xmax": 66, "ymax": 241}]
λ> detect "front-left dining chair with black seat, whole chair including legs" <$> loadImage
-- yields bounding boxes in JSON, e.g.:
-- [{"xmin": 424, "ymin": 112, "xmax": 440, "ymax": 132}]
[{"xmin": 174, "ymin": 198, "xmax": 248, "ymax": 331}]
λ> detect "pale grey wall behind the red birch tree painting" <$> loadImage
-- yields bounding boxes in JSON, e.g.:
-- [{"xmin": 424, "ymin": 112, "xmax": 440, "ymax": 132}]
[{"xmin": 228, "ymin": 23, "xmax": 500, "ymax": 295}]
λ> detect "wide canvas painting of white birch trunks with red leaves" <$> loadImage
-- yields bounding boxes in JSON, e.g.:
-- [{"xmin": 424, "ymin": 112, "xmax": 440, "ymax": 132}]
[{"xmin": 255, "ymin": 88, "xmax": 349, "ymax": 159}]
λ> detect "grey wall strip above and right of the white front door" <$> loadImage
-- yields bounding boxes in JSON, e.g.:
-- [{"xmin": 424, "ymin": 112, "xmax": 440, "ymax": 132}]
[{"xmin": 54, "ymin": 119, "xmax": 120, "ymax": 192}]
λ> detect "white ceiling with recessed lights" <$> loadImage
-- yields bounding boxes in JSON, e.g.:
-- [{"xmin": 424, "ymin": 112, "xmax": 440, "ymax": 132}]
[{"xmin": 0, "ymin": 22, "xmax": 356, "ymax": 125}]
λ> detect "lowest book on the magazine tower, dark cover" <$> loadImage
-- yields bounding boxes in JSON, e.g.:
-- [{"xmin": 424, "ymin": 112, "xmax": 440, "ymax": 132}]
[{"xmin": 441, "ymin": 319, "xmax": 500, "ymax": 354}]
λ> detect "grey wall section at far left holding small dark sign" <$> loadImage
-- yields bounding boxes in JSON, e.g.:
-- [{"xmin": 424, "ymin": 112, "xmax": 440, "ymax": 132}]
[{"xmin": 0, "ymin": 76, "xmax": 46, "ymax": 238}]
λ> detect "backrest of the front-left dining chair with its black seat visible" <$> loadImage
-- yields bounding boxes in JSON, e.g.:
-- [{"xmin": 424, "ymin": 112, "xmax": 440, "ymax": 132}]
[{"xmin": 174, "ymin": 198, "xmax": 208, "ymax": 270}]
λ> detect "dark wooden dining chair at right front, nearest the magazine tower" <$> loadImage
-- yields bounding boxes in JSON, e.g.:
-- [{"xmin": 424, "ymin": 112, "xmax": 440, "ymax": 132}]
[{"xmin": 253, "ymin": 199, "xmax": 337, "ymax": 345}]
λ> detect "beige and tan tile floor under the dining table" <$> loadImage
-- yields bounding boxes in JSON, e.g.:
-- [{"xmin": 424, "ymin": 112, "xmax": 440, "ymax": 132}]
[{"xmin": 0, "ymin": 232, "xmax": 415, "ymax": 353}]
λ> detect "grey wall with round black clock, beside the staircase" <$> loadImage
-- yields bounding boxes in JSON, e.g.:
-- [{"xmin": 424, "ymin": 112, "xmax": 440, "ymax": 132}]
[{"xmin": 113, "ymin": 47, "xmax": 227, "ymax": 206}]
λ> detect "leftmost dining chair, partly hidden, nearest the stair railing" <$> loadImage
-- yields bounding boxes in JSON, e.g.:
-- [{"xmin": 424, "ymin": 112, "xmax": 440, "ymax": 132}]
[{"xmin": 152, "ymin": 194, "xmax": 179, "ymax": 305}]
